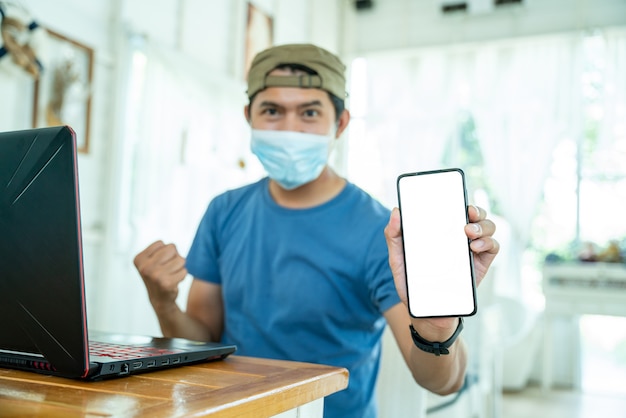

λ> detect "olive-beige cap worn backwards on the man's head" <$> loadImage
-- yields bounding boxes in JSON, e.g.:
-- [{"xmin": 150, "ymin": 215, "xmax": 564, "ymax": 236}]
[{"xmin": 247, "ymin": 44, "xmax": 346, "ymax": 99}]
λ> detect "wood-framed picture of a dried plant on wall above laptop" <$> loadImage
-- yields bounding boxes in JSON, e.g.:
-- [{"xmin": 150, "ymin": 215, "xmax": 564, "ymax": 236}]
[{"xmin": 33, "ymin": 29, "xmax": 93, "ymax": 153}]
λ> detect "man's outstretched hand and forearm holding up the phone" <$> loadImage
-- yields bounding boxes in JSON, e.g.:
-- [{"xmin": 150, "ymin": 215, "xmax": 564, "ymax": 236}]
[{"xmin": 384, "ymin": 206, "xmax": 499, "ymax": 395}]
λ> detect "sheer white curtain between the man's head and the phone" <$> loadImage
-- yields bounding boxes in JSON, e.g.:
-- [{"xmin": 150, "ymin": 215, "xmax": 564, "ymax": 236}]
[{"xmin": 348, "ymin": 51, "xmax": 457, "ymax": 207}]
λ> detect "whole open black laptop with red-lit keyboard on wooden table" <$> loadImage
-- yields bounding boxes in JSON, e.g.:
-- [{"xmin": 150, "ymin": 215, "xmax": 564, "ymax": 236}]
[{"xmin": 0, "ymin": 126, "xmax": 236, "ymax": 380}]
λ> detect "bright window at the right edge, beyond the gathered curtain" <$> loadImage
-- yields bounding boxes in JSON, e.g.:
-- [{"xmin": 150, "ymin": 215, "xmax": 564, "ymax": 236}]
[{"xmin": 526, "ymin": 34, "xmax": 626, "ymax": 303}]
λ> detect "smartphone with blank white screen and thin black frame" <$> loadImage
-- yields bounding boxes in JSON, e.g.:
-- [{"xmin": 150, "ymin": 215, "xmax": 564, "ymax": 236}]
[{"xmin": 397, "ymin": 168, "xmax": 477, "ymax": 318}]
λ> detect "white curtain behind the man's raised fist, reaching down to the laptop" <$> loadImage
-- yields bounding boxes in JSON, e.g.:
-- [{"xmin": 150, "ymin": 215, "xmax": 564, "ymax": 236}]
[{"xmin": 94, "ymin": 37, "xmax": 262, "ymax": 335}]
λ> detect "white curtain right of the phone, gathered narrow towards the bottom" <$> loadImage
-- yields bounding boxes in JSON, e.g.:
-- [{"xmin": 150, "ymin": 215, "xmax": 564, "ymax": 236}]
[{"xmin": 472, "ymin": 34, "xmax": 582, "ymax": 297}]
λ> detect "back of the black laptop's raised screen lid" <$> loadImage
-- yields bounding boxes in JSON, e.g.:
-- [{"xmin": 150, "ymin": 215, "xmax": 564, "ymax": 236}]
[{"xmin": 0, "ymin": 127, "xmax": 88, "ymax": 377}]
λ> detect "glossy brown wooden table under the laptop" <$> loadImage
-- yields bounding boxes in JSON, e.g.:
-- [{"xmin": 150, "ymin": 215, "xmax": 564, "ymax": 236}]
[{"xmin": 0, "ymin": 355, "xmax": 348, "ymax": 418}]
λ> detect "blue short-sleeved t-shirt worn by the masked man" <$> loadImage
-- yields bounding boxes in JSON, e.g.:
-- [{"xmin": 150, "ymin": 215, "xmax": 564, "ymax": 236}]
[{"xmin": 187, "ymin": 178, "xmax": 400, "ymax": 418}]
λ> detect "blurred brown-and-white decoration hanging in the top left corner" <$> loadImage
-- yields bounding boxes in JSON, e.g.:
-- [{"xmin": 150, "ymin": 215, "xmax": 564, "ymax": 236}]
[{"xmin": 0, "ymin": 1, "xmax": 45, "ymax": 79}]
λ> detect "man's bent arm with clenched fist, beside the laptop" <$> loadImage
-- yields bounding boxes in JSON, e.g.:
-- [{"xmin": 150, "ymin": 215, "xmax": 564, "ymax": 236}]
[{"xmin": 134, "ymin": 241, "xmax": 224, "ymax": 341}]
